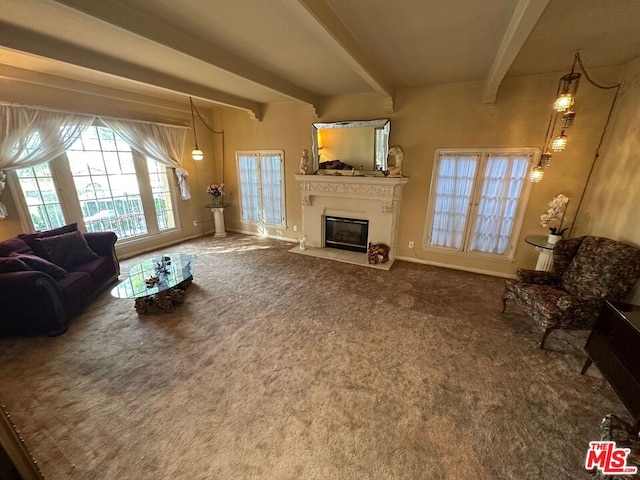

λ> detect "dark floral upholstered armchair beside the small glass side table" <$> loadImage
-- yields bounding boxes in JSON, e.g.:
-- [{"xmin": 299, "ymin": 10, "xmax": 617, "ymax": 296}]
[{"xmin": 502, "ymin": 236, "xmax": 640, "ymax": 348}]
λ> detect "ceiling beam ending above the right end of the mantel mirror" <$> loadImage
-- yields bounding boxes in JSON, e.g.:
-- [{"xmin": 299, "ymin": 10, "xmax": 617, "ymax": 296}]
[{"xmin": 280, "ymin": 0, "xmax": 395, "ymax": 113}]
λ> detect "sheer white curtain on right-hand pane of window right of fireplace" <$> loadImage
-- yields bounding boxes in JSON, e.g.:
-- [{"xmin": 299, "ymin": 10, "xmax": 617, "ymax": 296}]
[{"xmin": 469, "ymin": 155, "xmax": 529, "ymax": 255}]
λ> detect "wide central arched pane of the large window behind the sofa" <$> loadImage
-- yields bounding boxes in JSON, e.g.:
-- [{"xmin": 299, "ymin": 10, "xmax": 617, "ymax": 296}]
[{"xmin": 67, "ymin": 126, "xmax": 147, "ymax": 238}]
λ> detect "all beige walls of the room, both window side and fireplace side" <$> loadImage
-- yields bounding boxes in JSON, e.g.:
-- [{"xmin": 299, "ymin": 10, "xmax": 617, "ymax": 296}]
[{"xmin": 0, "ymin": 63, "xmax": 640, "ymax": 276}]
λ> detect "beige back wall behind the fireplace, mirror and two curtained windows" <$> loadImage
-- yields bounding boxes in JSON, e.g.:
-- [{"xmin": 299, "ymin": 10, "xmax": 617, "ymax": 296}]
[{"xmin": 218, "ymin": 69, "xmax": 620, "ymax": 276}]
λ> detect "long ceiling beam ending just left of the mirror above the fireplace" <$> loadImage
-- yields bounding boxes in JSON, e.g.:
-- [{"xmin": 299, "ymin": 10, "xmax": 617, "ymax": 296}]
[{"xmin": 48, "ymin": 0, "xmax": 318, "ymax": 107}]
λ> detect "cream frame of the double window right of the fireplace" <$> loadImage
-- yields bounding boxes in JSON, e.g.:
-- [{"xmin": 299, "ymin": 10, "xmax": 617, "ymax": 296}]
[{"xmin": 421, "ymin": 147, "xmax": 541, "ymax": 262}]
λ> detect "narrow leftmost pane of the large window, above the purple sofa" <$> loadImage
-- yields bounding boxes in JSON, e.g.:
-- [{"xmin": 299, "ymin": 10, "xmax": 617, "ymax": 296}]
[{"xmin": 16, "ymin": 163, "xmax": 66, "ymax": 230}]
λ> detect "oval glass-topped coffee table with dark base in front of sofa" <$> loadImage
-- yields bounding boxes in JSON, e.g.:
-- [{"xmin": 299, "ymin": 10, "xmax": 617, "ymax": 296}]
[{"xmin": 111, "ymin": 253, "xmax": 196, "ymax": 313}]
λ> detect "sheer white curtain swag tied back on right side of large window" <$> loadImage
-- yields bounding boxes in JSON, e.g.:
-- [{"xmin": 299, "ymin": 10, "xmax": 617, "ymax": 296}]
[{"xmin": 100, "ymin": 118, "xmax": 191, "ymax": 200}]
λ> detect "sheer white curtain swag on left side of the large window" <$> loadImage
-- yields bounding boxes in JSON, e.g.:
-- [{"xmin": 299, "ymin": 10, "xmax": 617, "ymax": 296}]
[{"xmin": 0, "ymin": 105, "xmax": 95, "ymax": 219}]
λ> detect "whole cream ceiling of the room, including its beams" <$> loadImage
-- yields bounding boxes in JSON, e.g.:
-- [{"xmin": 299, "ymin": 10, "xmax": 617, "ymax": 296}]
[{"xmin": 0, "ymin": 0, "xmax": 640, "ymax": 118}]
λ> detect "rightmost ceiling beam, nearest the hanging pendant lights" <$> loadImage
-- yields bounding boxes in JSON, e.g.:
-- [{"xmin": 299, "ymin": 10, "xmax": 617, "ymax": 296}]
[{"xmin": 482, "ymin": 0, "xmax": 550, "ymax": 103}]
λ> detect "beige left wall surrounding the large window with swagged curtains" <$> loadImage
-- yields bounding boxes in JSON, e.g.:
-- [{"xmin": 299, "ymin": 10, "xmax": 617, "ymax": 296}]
[{"xmin": 0, "ymin": 79, "xmax": 221, "ymax": 257}]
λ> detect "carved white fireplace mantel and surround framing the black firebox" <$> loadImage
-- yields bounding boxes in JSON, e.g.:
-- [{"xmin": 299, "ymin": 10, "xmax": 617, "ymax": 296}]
[{"xmin": 295, "ymin": 175, "xmax": 409, "ymax": 258}]
